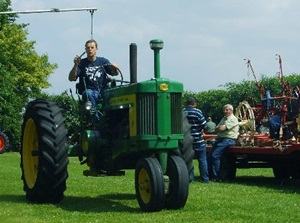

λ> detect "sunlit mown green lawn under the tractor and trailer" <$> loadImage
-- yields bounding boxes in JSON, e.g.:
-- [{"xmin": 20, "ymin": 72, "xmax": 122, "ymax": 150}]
[{"xmin": 0, "ymin": 153, "xmax": 300, "ymax": 223}]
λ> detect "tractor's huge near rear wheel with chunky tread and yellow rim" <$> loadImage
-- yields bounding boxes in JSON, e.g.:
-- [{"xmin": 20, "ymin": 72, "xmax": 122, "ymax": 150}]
[{"xmin": 21, "ymin": 100, "xmax": 69, "ymax": 203}]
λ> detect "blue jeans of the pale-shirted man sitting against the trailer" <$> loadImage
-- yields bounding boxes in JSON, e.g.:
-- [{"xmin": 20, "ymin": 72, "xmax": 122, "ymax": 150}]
[{"xmin": 207, "ymin": 139, "xmax": 235, "ymax": 179}]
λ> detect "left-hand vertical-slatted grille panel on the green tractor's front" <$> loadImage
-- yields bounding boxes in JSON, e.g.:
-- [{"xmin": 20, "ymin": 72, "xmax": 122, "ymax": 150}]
[{"xmin": 137, "ymin": 94, "xmax": 157, "ymax": 135}]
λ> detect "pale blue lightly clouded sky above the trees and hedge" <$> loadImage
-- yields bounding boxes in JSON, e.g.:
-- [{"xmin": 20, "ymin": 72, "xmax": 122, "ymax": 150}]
[{"xmin": 12, "ymin": 0, "xmax": 300, "ymax": 94}]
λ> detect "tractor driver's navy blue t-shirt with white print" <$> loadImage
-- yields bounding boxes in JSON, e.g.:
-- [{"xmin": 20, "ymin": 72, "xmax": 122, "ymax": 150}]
[{"xmin": 77, "ymin": 57, "xmax": 110, "ymax": 90}]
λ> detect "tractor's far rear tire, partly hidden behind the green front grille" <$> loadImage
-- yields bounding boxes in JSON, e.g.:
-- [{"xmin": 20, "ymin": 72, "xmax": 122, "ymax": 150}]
[{"xmin": 177, "ymin": 113, "xmax": 195, "ymax": 178}]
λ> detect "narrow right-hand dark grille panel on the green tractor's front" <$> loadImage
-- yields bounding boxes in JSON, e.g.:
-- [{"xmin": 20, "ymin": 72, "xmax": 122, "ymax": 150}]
[{"xmin": 171, "ymin": 93, "xmax": 182, "ymax": 134}]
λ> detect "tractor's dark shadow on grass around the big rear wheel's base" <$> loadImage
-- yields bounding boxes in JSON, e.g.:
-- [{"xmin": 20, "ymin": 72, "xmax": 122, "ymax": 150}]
[{"xmin": 0, "ymin": 193, "xmax": 141, "ymax": 213}]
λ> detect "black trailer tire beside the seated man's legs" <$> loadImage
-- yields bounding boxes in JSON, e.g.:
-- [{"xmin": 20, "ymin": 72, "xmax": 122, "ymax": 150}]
[{"xmin": 219, "ymin": 153, "xmax": 236, "ymax": 181}]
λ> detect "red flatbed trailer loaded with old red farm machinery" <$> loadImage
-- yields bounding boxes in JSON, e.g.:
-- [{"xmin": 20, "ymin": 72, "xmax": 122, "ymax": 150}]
[{"xmin": 204, "ymin": 55, "xmax": 300, "ymax": 180}]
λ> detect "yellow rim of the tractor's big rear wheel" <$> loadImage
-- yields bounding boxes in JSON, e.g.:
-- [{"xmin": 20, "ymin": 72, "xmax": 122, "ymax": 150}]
[{"xmin": 22, "ymin": 118, "xmax": 39, "ymax": 189}]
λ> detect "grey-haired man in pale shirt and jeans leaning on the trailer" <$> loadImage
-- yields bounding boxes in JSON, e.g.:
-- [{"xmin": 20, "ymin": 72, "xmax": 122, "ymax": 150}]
[{"xmin": 208, "ymin": 104, "xmax": 239, "ymax": 181}]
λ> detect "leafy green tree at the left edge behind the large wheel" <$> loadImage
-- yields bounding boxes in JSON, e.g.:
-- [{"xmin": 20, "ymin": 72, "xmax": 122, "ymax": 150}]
[{"xmin": 0, "ymin": 0, "xmax": 57, "ymax": 149}]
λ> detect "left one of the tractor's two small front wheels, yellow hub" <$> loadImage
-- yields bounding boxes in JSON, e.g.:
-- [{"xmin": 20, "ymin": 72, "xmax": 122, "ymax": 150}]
[{"xmin": 135, "ymin": 157, "xmax": 165, "ymax": 212}]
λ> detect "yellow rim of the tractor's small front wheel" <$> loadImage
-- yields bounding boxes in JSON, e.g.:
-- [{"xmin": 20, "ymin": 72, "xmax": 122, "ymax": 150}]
[{"xmin": 138, "ymin": 168, "xmax": 151, "ymax": 204}]
